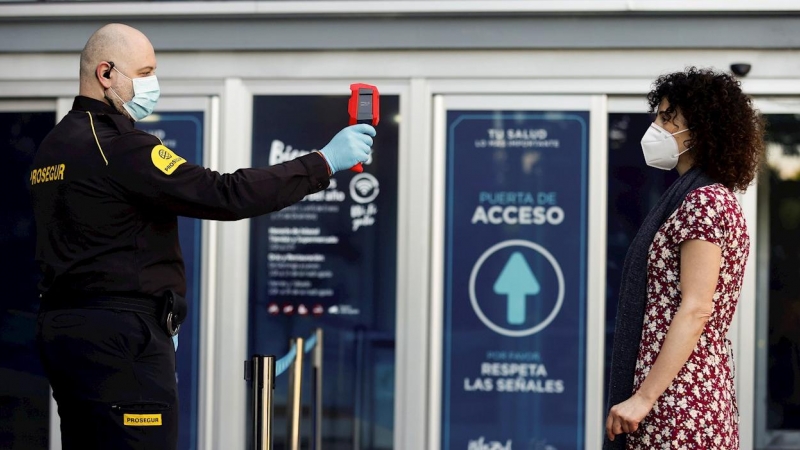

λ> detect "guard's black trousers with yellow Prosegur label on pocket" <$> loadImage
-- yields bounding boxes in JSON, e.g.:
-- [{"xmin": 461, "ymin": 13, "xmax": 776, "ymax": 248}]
[{"xmin": 37, "ymin": 309, "xmax": 178, "ymax": 450}]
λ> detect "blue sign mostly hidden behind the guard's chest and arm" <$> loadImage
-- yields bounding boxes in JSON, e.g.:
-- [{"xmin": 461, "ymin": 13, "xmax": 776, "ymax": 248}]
[{"xmin": 136, "ymin": 111, "xmax": 203, "ymax": 450}]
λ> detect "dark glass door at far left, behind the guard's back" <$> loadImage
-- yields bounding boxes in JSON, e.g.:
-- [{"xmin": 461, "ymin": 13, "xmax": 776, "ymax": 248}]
[{"xmin": 0, "ymin": 100, "xmax": 56, "ymax": 450}]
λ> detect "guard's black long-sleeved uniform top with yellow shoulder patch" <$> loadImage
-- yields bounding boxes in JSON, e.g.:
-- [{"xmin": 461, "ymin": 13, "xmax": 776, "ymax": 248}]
[{"xmin": 30, "ymin": 97, "xmax": 329, "ymax": 297}]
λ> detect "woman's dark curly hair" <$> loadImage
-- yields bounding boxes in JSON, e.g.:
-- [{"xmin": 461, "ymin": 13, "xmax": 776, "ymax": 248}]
[{"xmin": 647, "ymin": 67, "xmax": 764, "ymax": 191}]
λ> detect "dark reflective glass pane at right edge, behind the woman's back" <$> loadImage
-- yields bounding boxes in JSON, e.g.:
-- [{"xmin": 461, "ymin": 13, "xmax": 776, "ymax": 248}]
[{"xmin": 758, "ymin": 114, "xmax": 800, "ymax": 431}]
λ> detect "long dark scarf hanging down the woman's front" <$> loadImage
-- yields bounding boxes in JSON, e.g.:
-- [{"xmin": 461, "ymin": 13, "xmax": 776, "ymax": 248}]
[{"xmin": 603, "ymin": 167, "xmax": 714, "ymax": 450}]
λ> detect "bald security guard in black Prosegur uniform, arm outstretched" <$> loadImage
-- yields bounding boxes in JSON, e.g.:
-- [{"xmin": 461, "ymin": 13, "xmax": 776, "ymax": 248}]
[{"xmin": 30, "ymin": 24, "xmax": 375, "ymax": 450}]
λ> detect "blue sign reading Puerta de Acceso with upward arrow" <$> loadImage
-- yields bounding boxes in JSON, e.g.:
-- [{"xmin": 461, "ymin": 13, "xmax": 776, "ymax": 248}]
[{"xmin": 441, "ymin": 111, "xmax": 589, "ymax": 450}]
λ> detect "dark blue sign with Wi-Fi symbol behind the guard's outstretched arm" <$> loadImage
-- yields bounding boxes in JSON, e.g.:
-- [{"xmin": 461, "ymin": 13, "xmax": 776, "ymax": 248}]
[{"xmin": 250, "ymin": 95, "xmax": 400, "ymax": 449}]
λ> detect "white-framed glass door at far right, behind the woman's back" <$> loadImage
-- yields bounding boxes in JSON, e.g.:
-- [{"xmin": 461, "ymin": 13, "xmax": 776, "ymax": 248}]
[{"xmin": 756, "ymin": 98, "xmax": 800, "ymax": 449}]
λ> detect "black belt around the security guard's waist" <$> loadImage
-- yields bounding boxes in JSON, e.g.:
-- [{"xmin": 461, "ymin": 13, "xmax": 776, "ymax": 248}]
[{"xmin": 40, "ymin": 293, "xmax": 164, "ymax": 318}]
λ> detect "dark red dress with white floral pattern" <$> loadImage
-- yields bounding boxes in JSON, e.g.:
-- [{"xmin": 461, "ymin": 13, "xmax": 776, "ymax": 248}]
[{"xmin": 627, "ymin": 184, "xmax": 750, "ymax": 450}]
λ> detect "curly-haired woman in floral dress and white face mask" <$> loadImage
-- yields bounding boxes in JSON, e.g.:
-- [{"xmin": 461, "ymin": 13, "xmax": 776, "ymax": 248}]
[{"xmin": 605, "ymin": 67, "xmax": 764, "ymax": 450}]
